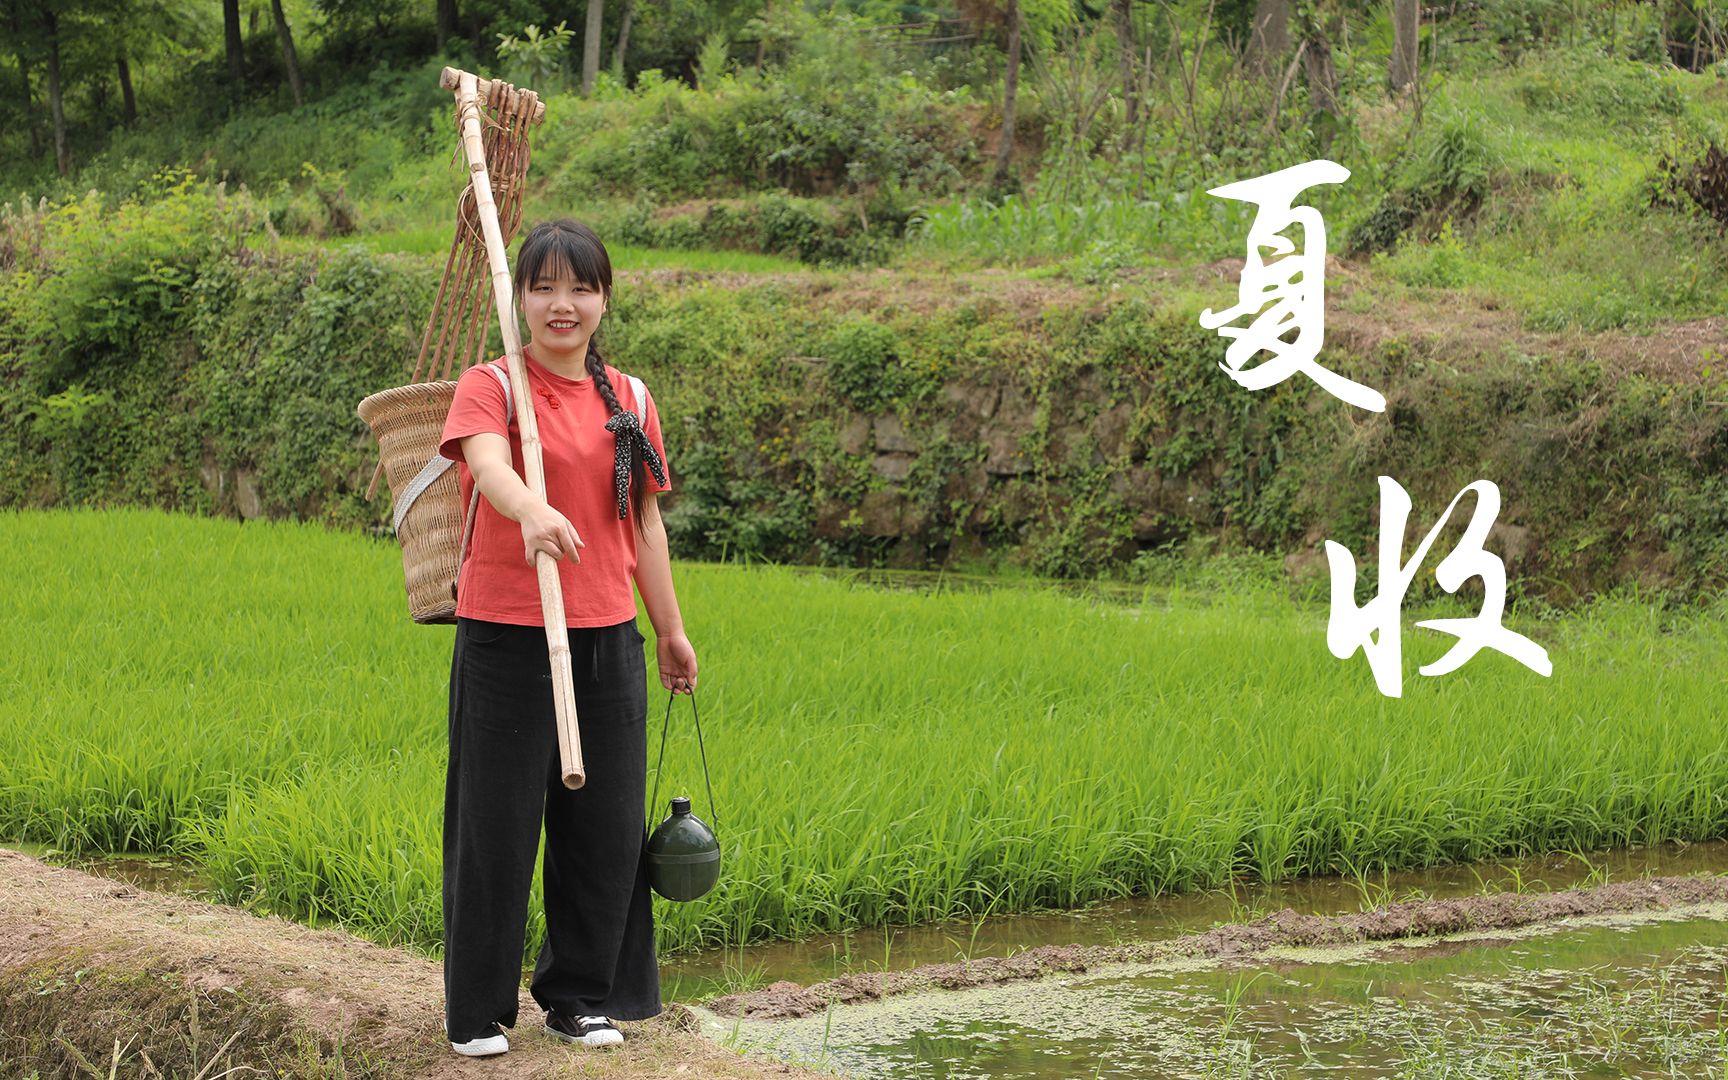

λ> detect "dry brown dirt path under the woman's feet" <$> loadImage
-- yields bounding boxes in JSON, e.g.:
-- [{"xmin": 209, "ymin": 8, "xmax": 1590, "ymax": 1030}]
[{"xmin": 0, "ymin": 848, "xmax": 819, "ymax": 1080}]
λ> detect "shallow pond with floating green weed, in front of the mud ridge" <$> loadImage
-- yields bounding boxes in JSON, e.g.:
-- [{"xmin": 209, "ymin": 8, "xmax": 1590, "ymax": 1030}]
[{"xmin": 703, "ymin": 905, "xmax": 1728, "ymax": 1080}]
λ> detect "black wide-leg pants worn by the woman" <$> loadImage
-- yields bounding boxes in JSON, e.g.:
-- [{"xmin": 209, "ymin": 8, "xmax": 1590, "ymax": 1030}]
[{"xmin": 444, "ymin": 619, "xmax": 660, "ymax": 1042}]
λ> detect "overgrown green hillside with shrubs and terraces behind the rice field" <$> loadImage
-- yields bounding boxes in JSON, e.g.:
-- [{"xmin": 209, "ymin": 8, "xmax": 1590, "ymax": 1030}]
[{"xmin": 0, "ymin": 3, "xmax": 1728, "ymax": 603}]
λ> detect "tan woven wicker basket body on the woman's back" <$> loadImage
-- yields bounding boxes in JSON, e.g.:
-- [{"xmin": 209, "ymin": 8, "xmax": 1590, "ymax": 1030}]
[{"xmin": 359, "ymin": 382, "xmax": 463, "ymax": 622}]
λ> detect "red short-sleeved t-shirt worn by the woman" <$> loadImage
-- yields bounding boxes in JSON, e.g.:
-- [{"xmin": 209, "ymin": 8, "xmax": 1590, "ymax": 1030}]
[{"xmin": 439, "ymin": 353, "xmax": 672, "ymax": 627}]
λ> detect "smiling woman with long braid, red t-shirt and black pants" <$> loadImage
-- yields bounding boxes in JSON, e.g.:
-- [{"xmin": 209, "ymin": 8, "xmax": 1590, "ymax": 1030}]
[{"xmin": 439, "ymin": 219, "xmax": 696, "ymax": 1058}]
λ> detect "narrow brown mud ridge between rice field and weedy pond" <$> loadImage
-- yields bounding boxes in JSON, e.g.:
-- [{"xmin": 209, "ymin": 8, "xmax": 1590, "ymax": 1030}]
[{"xmin": 707, "ymin": 878, "xmax": 1728, "ymax": 1020}]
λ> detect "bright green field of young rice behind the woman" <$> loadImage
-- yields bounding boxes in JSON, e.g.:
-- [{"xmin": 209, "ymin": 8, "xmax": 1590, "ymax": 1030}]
[{"xmin": 0, "ymin": 510, "xmax": 1728, "ymax": 956}]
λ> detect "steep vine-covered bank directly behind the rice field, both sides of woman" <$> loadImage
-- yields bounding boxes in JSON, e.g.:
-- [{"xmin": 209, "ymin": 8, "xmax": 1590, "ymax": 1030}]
[{"xmin": 0, "ymin": 180, "xmax": 1728, "ymax": 603}]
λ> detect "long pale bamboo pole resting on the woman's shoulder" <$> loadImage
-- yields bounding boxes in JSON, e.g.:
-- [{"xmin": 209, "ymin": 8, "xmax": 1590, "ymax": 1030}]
[{"xmin": 439, "ymin": 67, "xmax": 588, "ymax": 790}]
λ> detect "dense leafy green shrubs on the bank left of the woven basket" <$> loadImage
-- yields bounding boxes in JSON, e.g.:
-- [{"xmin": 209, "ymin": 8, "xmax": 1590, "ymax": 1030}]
[{"xmin": 0, "ymin": 175, "xmax": 432, "ymax": 525}]
